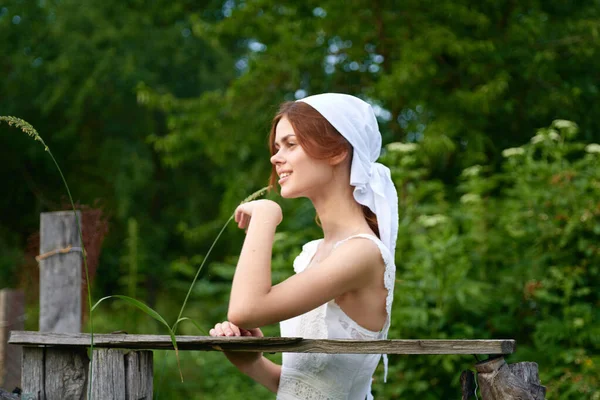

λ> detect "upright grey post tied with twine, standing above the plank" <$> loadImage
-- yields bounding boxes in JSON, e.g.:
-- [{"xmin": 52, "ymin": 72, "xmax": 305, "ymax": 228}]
[{"xmin": 39, "ymin": 211, "xmax": 83, "ymax": 333}]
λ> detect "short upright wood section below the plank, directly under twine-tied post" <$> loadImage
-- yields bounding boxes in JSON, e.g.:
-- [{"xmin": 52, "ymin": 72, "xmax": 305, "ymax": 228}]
[{"xmin": 44, "ymin": 348, "xmax": 88, "ymax": 400}]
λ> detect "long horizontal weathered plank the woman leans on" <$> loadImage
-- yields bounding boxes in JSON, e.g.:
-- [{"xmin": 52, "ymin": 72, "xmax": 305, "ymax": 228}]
[{"xmin": 9, "ymin": 331, "xmax": 515, "ymax": 355}]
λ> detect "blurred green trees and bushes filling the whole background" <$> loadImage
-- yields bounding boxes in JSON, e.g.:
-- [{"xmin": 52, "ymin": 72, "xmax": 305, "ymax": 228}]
[{"xmin": 0, "ymin": 0, "xmax": 600, "ymax": 399}]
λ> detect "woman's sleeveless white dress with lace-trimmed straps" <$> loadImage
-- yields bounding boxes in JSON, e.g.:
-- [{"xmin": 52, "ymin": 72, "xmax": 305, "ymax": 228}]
[{"xmin": 277, "ymin": 234, "xmax": 396, "ymax": 400}]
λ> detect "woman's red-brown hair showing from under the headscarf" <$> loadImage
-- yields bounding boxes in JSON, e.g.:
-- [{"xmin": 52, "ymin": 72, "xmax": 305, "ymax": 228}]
[{"xmin": 269, "ymin": 101, "xmax": 379, "ymax": 237}]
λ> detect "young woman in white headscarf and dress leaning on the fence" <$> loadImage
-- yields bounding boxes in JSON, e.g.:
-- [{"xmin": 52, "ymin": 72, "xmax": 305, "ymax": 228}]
[{"xmin": 210, "ymin": 93, "xmax": 398, "ymax": 400}]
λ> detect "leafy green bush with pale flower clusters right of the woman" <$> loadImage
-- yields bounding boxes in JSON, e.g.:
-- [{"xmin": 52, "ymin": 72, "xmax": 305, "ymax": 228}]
[{"xmin": 374, "ymin": 120, "xmax": 600, "ymax": 399}]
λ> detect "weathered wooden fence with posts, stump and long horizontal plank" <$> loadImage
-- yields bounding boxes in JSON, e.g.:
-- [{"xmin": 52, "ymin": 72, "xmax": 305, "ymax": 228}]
[{"xmin": 0, "ymin": 213, "xmax": 545, "ymax": 400}]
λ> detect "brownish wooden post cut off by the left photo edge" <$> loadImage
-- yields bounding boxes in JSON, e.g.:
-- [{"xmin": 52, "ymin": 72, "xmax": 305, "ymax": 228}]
[{"xmin": 0, "ymin": 289, "xmax": 25, "ymax": 390}]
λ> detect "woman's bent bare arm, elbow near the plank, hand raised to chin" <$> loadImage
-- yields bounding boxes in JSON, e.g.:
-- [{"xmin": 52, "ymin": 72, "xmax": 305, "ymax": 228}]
[{"xmin": 227, "ymin": 200, "xmax": 384, "ymax": 329}]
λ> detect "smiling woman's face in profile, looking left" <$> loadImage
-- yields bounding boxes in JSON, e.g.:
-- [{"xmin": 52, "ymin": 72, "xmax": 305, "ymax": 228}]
[{"xmin": 271, "ymin": 117, "xmax": 333, "ymax": 198}]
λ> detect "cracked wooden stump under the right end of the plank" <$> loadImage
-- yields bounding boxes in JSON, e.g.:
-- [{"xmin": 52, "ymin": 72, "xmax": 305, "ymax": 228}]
[{"xmin": 475, "ymin": 357, "xmax": 546, "ymax": 400}]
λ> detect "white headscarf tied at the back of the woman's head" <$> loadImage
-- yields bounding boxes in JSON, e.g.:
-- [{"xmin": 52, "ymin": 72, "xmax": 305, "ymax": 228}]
[{"xmin": 298, "ymin": 93, "xmax": 398, "ymax": 259}]
